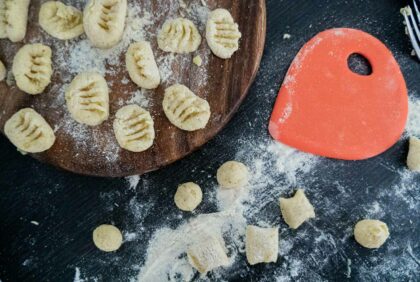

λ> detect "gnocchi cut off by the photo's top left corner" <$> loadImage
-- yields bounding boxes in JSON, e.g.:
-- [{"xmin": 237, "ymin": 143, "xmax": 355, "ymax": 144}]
[{"xmin": 0, "ymin": 0, "xmax": 30, "ymax": 42}]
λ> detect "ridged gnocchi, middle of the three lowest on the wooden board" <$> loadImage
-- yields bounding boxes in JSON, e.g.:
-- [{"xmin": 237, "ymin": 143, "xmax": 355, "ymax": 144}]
[{"xmin": 114, "ymin": 105, "xmax": 155, "ymax": 152}]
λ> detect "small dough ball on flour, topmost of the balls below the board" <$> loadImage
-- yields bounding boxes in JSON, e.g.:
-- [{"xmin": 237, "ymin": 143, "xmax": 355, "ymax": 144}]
[{"xmin": 217, "ymin": 161, "xmax": 249, "ymax": 189}]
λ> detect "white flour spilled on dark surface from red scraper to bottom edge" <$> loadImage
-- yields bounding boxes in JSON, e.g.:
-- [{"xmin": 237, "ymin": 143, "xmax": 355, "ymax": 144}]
[{"xmin": 138, "ymin": 140, "xmax": 318, "ymax": 281}]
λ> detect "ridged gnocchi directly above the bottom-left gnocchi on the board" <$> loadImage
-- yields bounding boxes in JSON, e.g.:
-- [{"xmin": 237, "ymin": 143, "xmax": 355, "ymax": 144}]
[{"xmin": 12, "ymin": 44, "xmax": 52, "ymax": 95}]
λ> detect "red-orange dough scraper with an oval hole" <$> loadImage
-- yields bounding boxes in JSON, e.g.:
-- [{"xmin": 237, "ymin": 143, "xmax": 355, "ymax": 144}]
[{"xmin": 269, "ymin": 28, "xmax": 408, "ymax": 160}]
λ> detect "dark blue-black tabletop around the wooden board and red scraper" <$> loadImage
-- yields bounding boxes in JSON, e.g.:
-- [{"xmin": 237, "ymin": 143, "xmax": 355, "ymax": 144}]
[{"xmin": 0, "ymin": 0, "xmax": 420, "ymax": 281}]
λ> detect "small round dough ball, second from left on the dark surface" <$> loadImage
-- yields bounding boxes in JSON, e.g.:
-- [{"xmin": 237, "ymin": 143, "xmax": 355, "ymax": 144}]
[{"xmin": 175, "ymin": 182, "xmax": 203, "ymax": 211}]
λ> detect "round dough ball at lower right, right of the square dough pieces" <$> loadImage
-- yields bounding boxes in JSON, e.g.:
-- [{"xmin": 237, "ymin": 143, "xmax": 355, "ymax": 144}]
[{"xmin": 354, "ymin": 219, "xmax": 389, "ymax": 249}]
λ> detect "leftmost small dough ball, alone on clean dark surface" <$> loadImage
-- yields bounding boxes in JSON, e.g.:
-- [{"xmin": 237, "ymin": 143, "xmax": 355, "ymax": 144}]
[{"xmin": 93, "ymin": 224, "xmax": 123, "ymax": 252}]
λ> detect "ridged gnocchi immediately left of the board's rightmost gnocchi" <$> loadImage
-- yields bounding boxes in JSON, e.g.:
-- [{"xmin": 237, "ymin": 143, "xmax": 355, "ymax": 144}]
[{"xmin": 158, "ymin": 18, "xmax": 201, "ymax": 53}]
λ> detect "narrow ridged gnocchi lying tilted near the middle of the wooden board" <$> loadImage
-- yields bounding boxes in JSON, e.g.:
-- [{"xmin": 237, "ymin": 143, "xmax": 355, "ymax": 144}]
[{"xmin": 125, "ymin": 41, "xmax": 160, "ymax": 89}]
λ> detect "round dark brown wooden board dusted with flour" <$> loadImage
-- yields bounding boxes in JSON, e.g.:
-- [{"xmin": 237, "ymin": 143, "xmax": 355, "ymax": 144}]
[{"xmin": 0, "ymin": 0, "xmax": 266, "ymax": 177}]
